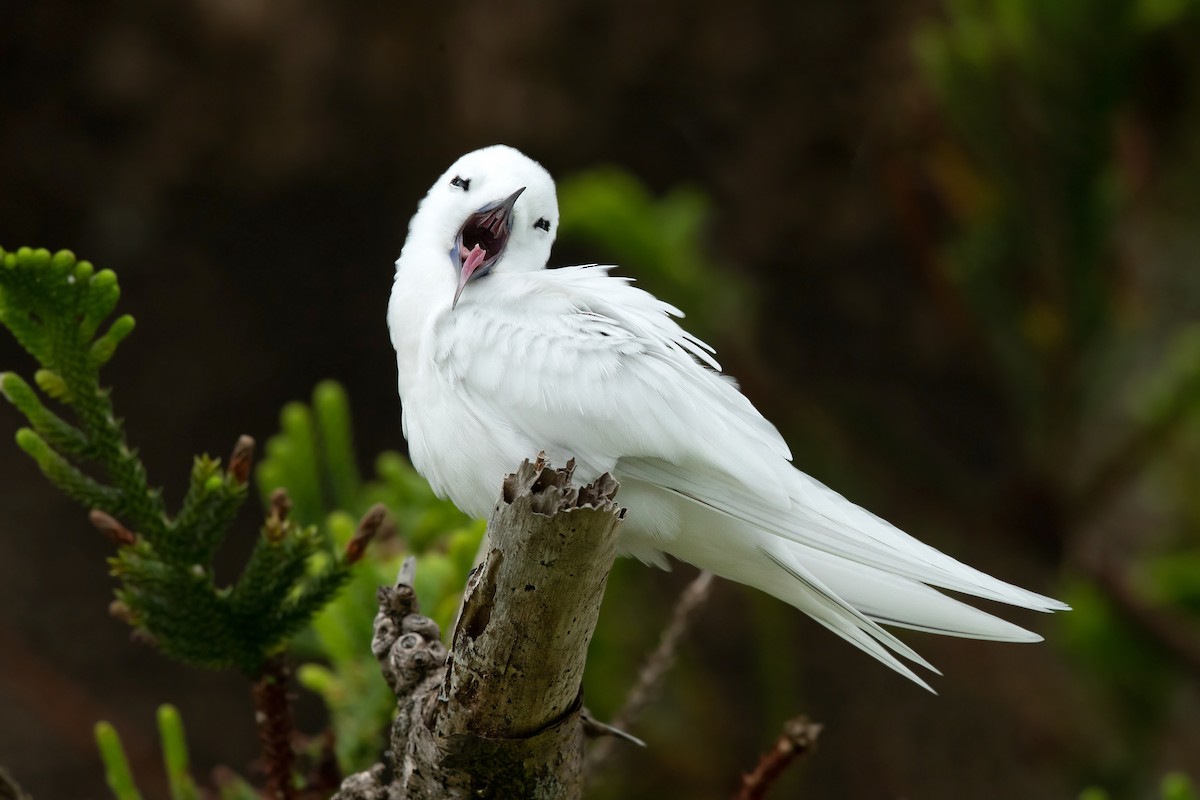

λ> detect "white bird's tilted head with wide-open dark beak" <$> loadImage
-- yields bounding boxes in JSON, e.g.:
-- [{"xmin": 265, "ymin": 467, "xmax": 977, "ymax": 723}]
[{"xmin": 409, "ymin": 145, "xmax": 558, "ymax": 305}]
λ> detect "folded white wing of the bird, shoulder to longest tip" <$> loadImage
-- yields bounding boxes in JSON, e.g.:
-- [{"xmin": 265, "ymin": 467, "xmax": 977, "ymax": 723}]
[{"xmin": 434, "ymin": 267, "xmax": 1064, "ymax": 610}]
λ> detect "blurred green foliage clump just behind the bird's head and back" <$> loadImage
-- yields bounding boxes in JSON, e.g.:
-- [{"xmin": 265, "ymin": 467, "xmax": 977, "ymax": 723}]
[{"xmin": 558, "ymin": 167, "xmax": 754, "ymax": 338}]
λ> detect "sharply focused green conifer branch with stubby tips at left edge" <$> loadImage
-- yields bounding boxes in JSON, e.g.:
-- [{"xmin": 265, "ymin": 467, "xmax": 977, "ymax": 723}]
[{"xmin": 0, "ymin": 248, "xmax": 349, "ymax": 674}]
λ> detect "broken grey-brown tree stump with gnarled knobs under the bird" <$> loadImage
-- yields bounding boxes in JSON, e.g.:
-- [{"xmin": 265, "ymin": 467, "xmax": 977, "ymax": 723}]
[{"xmin": 336, "ymin": 458, "xmax": 624, "ymax": 800}]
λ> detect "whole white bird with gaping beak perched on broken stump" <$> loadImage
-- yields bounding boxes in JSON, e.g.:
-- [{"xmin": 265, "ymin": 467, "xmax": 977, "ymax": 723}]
[{"xmin": 388, "ymin": 145, "xmax": 1067, "ymax": 688}]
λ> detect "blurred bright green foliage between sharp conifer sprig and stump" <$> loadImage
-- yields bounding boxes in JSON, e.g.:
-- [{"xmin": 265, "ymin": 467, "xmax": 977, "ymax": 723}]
[{"xmin": 257, "ymin": 381, "xmax": 484, "ymax": 774}]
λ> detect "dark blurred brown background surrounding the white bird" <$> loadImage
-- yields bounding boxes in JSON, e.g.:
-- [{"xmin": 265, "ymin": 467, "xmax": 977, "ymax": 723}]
[{"xmin": 0, "ymin": 0, "xmax": 1200, "ymax": 799}]
